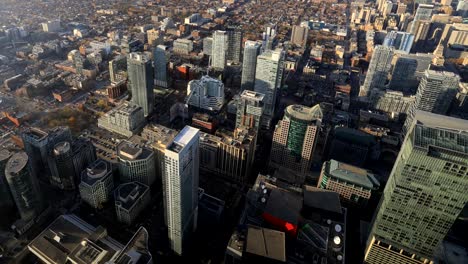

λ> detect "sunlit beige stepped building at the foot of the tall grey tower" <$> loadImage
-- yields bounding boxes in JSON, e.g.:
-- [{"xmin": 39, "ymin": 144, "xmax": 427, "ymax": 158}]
[{"xmin": 98, "ymin": 103, "xmax": 145, "ymax": 137}]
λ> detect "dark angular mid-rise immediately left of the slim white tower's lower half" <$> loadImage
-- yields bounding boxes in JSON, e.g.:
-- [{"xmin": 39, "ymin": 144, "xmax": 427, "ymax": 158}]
[{"xmin": 114, "ymin": 182, "xmax": 151, "ymax": 225}]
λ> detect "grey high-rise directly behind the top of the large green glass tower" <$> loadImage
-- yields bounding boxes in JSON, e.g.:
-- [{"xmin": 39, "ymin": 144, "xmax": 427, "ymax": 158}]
[{"xmin": 403, "ymin": 70, "xmax": 460, "ymax": 134}]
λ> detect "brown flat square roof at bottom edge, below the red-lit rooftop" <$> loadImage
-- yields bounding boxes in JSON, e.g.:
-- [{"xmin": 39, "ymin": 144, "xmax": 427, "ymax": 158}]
[{"xmin": 245, "ymin": 225, "xmax": 286, "ymax": 262}]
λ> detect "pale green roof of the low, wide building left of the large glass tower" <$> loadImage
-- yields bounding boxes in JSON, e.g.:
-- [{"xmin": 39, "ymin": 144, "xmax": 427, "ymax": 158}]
[{"xmin": 323, "ymin": 159, "xmax": 380, "ymax": 189}]
